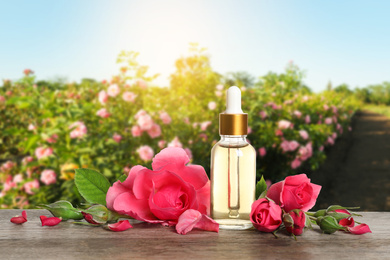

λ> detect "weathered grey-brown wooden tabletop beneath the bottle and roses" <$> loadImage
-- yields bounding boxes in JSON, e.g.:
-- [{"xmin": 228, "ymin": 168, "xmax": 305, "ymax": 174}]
[{"xmin": 0, "ymin": 210, "xmax": 390, "ymax": 260}]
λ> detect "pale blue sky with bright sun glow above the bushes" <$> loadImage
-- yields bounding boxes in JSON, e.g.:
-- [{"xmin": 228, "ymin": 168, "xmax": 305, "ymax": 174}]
[{"xmin": 0, "ymin": 0, "xmax": 390, "ymax": 92}]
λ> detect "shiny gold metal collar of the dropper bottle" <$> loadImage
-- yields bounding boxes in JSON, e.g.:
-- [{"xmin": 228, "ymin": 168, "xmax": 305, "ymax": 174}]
[{"xmin": 219, "ymin": 113, "xmax": 248, "ymax": 135}]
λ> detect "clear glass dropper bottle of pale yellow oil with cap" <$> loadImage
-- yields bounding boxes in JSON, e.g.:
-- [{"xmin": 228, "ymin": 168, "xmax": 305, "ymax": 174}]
[{"xmin": 210, "ymin": 86, "xmax": 256, "ymax": 230}]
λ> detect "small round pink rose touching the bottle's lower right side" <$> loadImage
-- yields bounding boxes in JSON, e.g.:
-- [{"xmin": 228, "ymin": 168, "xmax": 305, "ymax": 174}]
[{"xmin": 250, "ymin": 198, "xmax": 282, "ymax": 232}]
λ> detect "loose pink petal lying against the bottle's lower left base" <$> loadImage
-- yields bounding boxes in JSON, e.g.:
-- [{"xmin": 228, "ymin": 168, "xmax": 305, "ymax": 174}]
[{"xmin": 176, "ymin": 209, "xmax": 219, "ymax": 235}]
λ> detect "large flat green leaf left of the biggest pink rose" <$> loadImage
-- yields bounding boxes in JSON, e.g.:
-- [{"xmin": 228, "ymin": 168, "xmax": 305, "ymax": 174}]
[{"xmin": 75, "ymin": 169, "xmax": 111, "ymax": 205}]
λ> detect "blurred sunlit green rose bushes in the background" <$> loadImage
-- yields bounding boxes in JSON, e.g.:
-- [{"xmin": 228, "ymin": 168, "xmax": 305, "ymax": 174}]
[{"xmin": 0, "ymin": 44, "xmax": 360, "ymax": 208}]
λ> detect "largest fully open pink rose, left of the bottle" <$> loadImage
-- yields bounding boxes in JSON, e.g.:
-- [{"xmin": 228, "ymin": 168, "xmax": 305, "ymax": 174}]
[{"xmin": 106, "ymin": 147, "xmax": 210, "ymax": 225}]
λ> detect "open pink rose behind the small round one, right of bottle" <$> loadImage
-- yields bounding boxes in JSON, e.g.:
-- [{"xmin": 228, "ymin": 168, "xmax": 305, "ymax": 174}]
[{"xmin": 267, "ymin": 174, "xmax": 321, "ymax": 212}]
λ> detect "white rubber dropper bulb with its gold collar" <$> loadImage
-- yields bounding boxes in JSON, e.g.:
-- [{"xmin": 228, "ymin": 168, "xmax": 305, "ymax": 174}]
[{"xmin": 219, "ymin": 86, "xmax": 248, "ymax": 135}]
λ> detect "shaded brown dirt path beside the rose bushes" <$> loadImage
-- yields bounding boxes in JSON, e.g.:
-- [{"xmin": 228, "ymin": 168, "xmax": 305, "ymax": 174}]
[{"xmin": 310, "ymin": 111, "xmax": 390, "ymax": 211}]
